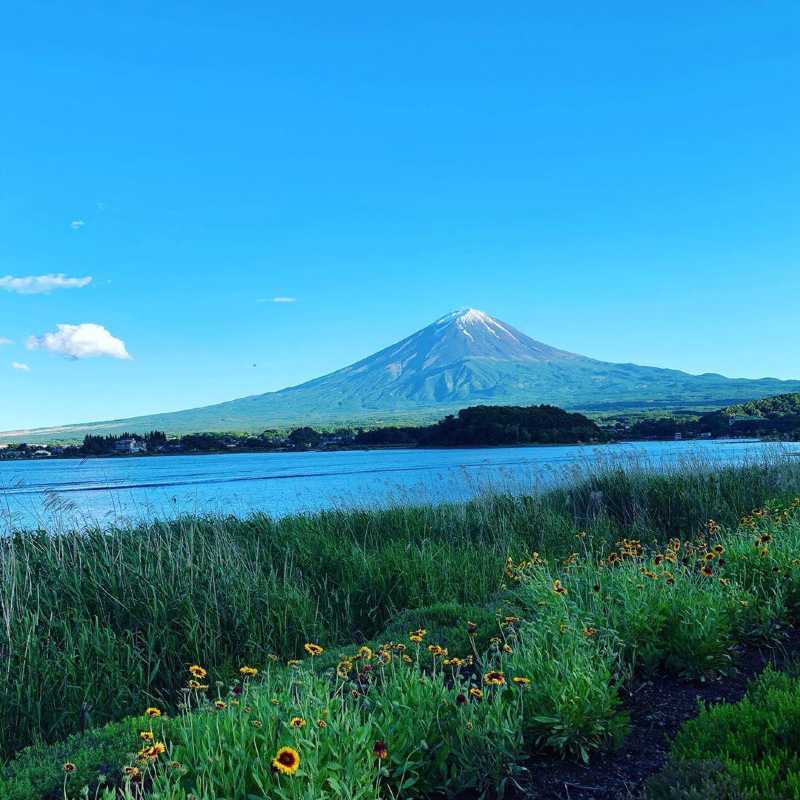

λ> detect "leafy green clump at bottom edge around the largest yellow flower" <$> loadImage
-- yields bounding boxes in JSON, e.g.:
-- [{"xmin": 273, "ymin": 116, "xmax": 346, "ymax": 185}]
[{"xmin": 159, "ymin": 668, "xmax": 378, "ymax": 800}]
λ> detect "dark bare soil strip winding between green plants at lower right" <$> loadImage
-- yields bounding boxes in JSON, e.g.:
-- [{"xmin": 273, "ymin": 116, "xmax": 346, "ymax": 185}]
[{"xmin": 515, "ymin": 629, "xmax": 800, "ymax": 800}]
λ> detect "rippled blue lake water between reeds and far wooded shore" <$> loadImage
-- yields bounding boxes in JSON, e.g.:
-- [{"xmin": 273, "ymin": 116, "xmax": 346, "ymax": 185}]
[{"xmin": 0, "ymin": 440, "xmax": 800, "ymax": 531}]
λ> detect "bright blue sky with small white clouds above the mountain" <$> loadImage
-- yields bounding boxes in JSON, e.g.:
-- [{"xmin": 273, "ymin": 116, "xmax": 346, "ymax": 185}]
[{"xmin": 0, "ymin": 0, "xmax": 800, "ymax": 429}]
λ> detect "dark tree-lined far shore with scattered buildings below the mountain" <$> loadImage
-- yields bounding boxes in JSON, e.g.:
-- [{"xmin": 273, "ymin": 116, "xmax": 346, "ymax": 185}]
[{"xmin": 0, "ymin": 394, "xmax": 800, "ymax": 460}]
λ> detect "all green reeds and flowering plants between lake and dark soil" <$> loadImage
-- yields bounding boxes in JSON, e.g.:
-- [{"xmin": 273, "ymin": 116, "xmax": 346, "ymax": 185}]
[{"xmin": 0, "ymin": 460, "xmax": 800, "ymax": 800}]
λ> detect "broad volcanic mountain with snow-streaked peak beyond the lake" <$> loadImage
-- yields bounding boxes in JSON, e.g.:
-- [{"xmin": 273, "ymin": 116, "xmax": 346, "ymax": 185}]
[{"xmin": 0, "ymin": 308, "xmax": 800, "ymax": 441}]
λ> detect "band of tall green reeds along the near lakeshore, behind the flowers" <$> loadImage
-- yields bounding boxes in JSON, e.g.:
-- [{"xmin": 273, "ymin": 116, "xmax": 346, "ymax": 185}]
[{"xmin": 0, "ymin": 458, "xmax": 800, "ymax": 755}]
